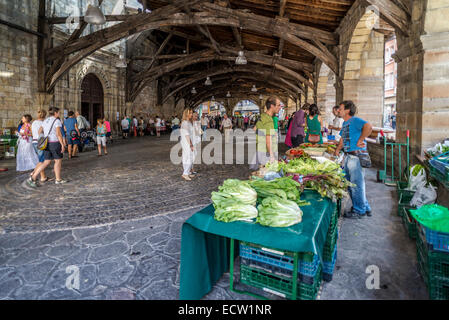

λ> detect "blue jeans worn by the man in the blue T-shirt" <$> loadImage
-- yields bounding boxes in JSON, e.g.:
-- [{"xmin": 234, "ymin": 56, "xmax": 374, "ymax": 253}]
[{"xmin": 344, "ymin": 154, "xmax": 371, "ymax": 214}]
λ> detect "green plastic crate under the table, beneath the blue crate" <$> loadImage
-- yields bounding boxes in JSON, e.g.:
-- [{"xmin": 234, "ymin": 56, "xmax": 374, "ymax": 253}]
[{"xmin": 240, "ymin": 264, "xmax": 322, "ymax": 300}]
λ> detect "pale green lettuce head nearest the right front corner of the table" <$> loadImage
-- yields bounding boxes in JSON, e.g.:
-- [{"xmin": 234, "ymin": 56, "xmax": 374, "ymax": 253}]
[{"xmin": 256, "ymin": 197, "xmax": 302, "ymax": 227}]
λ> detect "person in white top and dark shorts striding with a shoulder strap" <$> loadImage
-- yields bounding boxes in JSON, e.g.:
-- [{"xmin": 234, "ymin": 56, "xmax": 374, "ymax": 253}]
[{"xmin": 27, "ymin": 107, "xmax": 67, "ymax": 188}]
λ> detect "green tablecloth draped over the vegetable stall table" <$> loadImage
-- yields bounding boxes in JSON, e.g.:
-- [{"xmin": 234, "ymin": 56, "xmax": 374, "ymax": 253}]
[{"xmin": 179, "ymin": 192, "xmax": 336, "ymax": 300}]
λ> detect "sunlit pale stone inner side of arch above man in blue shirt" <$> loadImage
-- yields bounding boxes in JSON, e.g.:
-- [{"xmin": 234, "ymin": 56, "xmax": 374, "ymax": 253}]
[{"xmin": 343, "ymin": 11, "xmax": 384, "ymax": 126}]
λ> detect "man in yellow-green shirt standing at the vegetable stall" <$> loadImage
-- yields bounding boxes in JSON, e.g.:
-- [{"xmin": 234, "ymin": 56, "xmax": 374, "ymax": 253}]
[{"xmin": 250, "ymin": 97, "xmax": 281, "ymax": 170}]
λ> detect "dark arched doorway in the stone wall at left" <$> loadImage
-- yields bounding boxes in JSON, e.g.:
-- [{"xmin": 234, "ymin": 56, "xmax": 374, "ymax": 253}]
[{"xmin": 81, "ymin": 73, "xmax": 104, "ymax": 127}]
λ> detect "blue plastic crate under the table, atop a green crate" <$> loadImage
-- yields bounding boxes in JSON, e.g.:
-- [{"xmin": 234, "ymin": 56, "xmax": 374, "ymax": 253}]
[{"xmin": 240, "ymin": 242, "xmax": 321, "ymax": 277}]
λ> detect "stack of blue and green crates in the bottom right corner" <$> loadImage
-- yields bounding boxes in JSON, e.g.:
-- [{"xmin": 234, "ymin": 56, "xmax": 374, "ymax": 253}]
[{"xmin": 416, "ymin": 223, "xmax": 449, "ymax": 300}]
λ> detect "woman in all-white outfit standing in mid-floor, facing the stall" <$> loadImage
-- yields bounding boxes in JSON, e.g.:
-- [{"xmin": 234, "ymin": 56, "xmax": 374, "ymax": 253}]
[{"xmin": 181, "ymin": 109, "xmax": 195, "ymax": 181}]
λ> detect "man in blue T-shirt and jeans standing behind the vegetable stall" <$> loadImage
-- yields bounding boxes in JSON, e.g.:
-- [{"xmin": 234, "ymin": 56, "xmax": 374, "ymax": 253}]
[{"xmin": 335, "ymin": 101, "xmax": 373, "ymax": 218}]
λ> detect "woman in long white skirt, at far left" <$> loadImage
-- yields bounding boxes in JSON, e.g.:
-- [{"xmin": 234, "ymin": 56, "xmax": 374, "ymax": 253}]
[{"xmin": 16, "ymin": 114, "xmax": 39, "ymax": 171}]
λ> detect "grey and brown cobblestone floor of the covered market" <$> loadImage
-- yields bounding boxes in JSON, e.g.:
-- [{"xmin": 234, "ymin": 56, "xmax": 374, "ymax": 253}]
[{"xmin": 0, "ymin": 137, "xmax": 426, "ymax": 299}]
